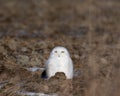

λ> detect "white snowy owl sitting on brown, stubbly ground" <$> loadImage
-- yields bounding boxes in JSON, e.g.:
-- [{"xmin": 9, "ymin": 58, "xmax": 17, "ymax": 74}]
[{"xmin": 43, "ymin": 46, "xmax": 73, "ymax": 79}]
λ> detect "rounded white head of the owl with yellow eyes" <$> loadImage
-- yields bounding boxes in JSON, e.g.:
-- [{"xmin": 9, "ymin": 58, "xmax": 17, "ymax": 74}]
[{"xmin": 50, "ymin": 46, "xmax": 70, "ymax": 58}]
